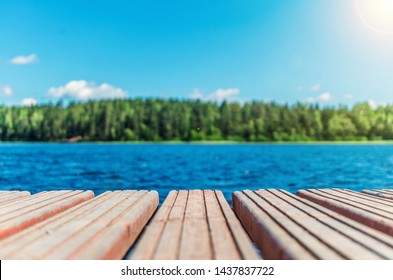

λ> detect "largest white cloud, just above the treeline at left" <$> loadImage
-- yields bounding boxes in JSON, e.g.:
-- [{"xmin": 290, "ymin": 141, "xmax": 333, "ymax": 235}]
[{"xmin": 48, "ymin": 80, "xmax": 128, "ymax": 100}]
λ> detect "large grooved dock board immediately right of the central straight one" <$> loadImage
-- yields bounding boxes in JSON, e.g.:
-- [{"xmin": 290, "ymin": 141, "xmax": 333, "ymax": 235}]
[{"xmin": 233, "ymin": 190, "xmax": 393, "ymax": 259}]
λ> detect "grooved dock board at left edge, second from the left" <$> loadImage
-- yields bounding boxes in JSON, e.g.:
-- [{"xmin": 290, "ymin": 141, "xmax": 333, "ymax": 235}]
[{"xmin": 0, "ymin": 191, "xmax": 94, "ymax": 240}]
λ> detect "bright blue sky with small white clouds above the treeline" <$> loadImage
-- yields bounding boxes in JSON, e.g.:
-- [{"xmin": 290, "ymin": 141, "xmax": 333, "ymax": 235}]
[{"xmin": 0, "ymin": 0, "xmax": 393, "ymax": 107}]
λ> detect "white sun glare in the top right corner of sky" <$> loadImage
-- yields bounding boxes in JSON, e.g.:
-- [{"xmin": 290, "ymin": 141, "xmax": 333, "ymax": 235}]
[{"xmin": 356, "ymin": 0, "xmax": 393, "ymax": 34}]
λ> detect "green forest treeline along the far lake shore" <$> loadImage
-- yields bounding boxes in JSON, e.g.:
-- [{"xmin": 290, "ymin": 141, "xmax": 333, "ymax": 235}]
[{"xmin": 0, "ymin": 99, "xmax": 393, "ymax": 141}]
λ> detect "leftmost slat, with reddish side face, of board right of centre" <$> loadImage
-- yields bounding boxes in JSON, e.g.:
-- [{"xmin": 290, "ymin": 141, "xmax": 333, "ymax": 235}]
[{"xmin": 232, "ymin": 190, "xmax": 316, "ymax": 259}]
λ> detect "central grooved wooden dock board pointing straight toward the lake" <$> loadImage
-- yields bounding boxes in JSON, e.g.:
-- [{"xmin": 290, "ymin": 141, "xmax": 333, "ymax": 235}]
[{"xmin": 130, "ymin": 190, "xmax": 260, "ymax": 260}]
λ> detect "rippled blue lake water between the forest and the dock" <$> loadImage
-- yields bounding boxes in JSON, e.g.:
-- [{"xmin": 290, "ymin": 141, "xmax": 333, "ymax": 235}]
[{"xmin": 0, "ymin": 144, "xmax": 393, "ymax": 201}]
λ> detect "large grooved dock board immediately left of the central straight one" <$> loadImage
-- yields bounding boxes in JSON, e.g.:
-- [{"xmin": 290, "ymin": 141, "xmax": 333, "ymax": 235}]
[{"xmin": 0, "ymin": 191, "xmax": 158, "ymax": 259}]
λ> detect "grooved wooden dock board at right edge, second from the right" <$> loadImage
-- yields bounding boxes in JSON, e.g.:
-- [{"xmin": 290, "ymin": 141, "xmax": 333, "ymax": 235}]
[{"xmin": 297, "ymin": 189, "xmax": 393, "ymax": 236}]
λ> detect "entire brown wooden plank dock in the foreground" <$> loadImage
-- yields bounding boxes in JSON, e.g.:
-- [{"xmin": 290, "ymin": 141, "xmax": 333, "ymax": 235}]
[{"xmin": 0, "ymin": 189, "xmax": 393, "ymax": 260}]
